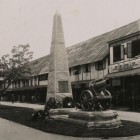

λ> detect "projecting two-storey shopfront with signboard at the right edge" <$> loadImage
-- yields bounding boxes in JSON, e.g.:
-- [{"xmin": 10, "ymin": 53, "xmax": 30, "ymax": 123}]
[{"xmin": 106, "ymin": 20, "xmax": 140, "ymax": 109}]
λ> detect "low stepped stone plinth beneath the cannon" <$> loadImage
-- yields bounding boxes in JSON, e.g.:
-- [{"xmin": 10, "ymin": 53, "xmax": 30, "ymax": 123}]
[{"xmin": 46, "ymin": 108, "xmax": 122, "ymax": 129}]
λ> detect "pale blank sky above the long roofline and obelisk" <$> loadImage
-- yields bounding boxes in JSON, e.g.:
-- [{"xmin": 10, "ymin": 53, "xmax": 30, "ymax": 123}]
[{"xmin": 0, "ymin": 0, "xmax": 140, "ymax": 59}]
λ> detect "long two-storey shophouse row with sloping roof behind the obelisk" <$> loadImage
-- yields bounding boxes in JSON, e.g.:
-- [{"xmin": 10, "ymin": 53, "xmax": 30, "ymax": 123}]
[{"xmin": 0, "ymin": 20, "xmax": 140, "ymax": 107}]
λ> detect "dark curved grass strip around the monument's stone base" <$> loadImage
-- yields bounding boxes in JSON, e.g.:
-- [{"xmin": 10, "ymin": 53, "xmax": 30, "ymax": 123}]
[{"xmin": 0, "ymin": 105, "xmax": 140, "ymax": 138}]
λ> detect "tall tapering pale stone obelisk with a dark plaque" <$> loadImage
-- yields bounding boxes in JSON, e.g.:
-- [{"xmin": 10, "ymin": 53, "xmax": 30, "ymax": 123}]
[{"xmin": 47, "ymin": 12, "xmax": 72, "ymax": 101}]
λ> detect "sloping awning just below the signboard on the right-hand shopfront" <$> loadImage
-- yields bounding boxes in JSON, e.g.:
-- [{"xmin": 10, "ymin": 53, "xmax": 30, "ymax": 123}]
[{"xmin": 105, "ymin": 68, "xmax": 140, "ymax": 78}]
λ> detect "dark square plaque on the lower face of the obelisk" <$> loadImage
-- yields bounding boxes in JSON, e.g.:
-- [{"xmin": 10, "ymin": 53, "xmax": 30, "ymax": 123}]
[{"xmin": 58, "ymin": 81, "xmax": 68, "ymax": 93}]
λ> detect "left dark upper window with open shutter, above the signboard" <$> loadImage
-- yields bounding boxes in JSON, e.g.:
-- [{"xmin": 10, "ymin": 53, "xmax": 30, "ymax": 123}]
[{"xmin": 113, "ymin": 45, "xmax": 124, "ymax": 62}]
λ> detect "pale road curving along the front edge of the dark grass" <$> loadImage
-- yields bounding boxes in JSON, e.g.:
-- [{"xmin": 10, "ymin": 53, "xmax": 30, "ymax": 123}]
[{"xmin": 0, "ymin": 118, "xmax": 140, "ymax": 140}]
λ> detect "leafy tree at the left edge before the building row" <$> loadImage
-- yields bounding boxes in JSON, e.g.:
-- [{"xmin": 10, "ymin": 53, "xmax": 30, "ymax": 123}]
[{"xmin": 0, "ymin": 44, "xmax": 33, "ymax": 94}]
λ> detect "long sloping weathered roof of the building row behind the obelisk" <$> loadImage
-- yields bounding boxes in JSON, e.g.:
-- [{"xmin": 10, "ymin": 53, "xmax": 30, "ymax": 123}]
[{"xmin": 30, "ymin": 20, "xmax": 140, "ymax": 75}]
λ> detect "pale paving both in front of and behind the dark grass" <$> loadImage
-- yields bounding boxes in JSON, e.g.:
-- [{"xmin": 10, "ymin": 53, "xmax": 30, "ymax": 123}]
[{"xmin": 0, "ymin": 101, "xmax": 140, "ymax": 140}]
